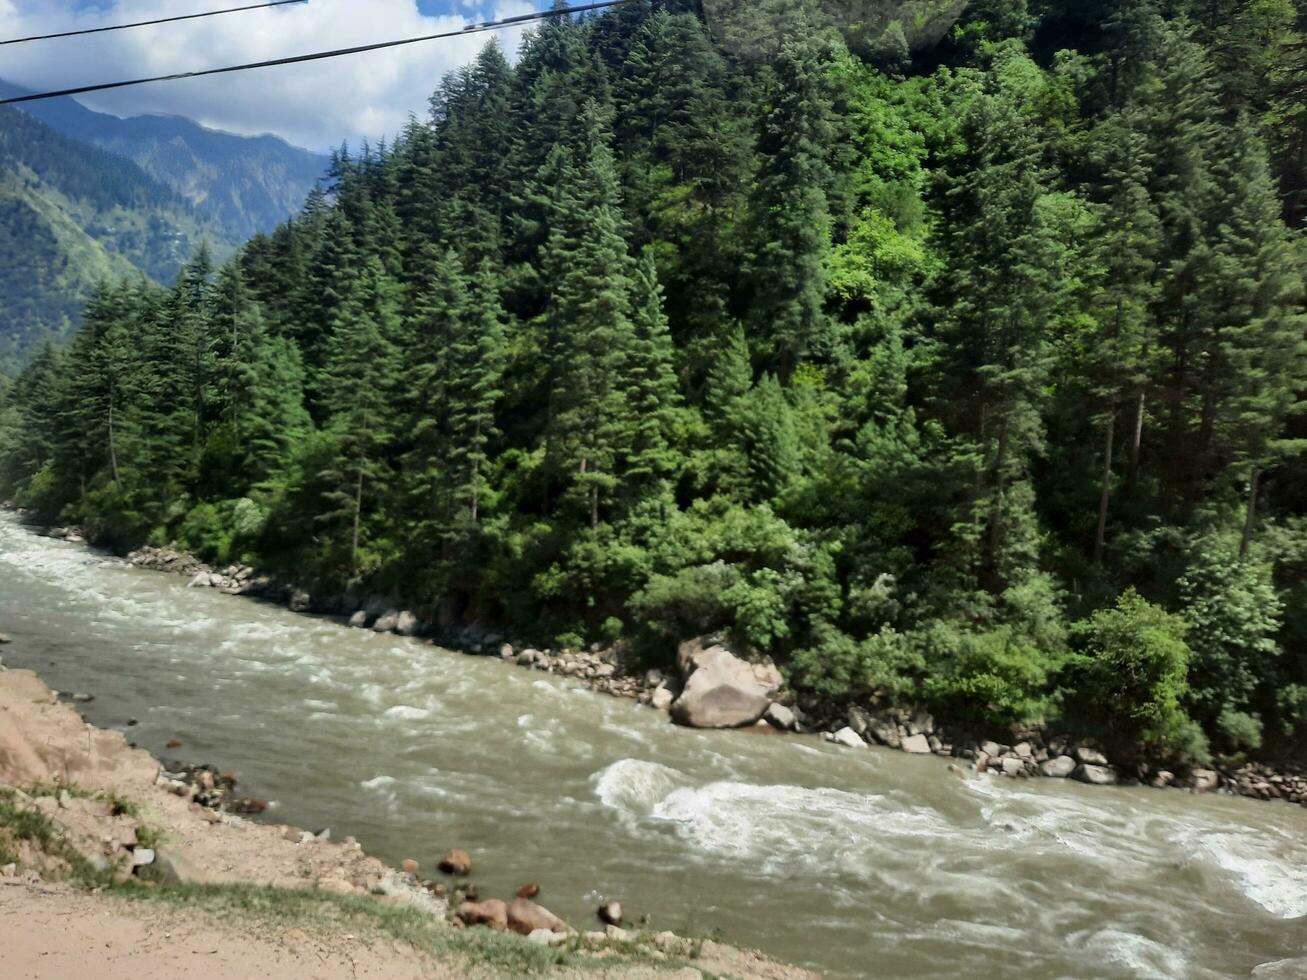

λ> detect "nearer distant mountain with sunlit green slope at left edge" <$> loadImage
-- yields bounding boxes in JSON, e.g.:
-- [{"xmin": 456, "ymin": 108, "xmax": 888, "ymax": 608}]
[{"xmin": 0, "ymin": 107, "xmax": 239, "ymax": 368}]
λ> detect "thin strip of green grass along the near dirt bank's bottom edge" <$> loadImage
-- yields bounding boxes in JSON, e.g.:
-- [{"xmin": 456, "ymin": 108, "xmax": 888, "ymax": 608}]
[{"xmin": 114, "ymin": 883, "xmax": 705, "ymax": 977}]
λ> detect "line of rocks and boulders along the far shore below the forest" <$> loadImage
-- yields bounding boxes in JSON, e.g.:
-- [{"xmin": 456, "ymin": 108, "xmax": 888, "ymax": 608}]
[{"xmin": 20, "ymin": 514, "xmax": 1307, "ymax": 806}]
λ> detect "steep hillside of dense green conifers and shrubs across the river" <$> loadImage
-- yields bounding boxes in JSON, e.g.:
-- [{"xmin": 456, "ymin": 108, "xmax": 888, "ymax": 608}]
[{"xmin": 0, "ymin": 0, "xmax": 1307, "ymax": 758}]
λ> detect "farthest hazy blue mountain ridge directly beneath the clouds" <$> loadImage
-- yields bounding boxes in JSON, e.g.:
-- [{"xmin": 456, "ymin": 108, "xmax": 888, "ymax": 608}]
[{"xmin": 0, "ymin": 81, "xmax": 327, "ymax": 240}]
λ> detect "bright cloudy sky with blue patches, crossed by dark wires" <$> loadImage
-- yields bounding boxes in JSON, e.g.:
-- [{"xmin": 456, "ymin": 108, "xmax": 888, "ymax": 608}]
[{"xmin": 0, "ymin": 0, "xmax": 540, "ymax": 150}]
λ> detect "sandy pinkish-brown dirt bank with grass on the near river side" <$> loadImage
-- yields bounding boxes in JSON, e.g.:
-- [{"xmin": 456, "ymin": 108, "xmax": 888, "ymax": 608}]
[{"xmin": 0, "ymin": 668, "xmax": 813, "ymax": 980}]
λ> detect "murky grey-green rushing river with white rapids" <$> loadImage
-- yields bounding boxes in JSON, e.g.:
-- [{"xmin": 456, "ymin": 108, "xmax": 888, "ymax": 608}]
[{"xmin": 0, "ymin": 515, "xmax": 1307, "ymax": 980}]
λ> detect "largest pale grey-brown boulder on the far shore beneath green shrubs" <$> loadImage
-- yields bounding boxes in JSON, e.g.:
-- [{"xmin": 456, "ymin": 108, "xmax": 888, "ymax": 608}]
[{"xmin": 672, "ymin": 638, "xmax": 782, "ymax": 728}]
